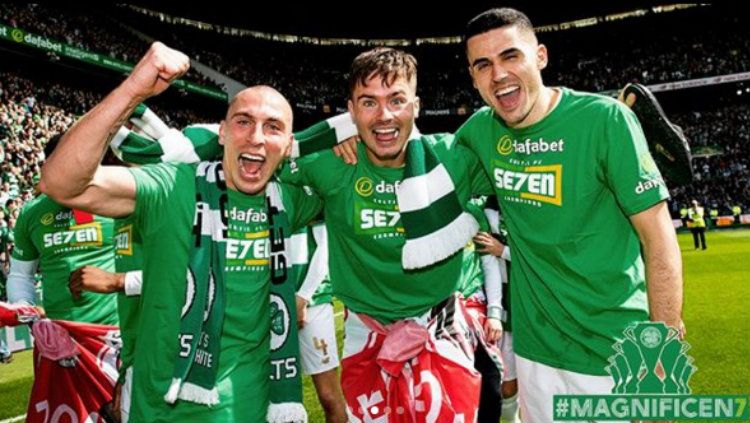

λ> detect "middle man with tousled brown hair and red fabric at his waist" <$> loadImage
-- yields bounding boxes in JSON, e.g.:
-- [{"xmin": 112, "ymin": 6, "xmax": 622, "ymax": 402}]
[{"xmin": 282, "ymin": 48, "xmax": 499, "ymax": 422}]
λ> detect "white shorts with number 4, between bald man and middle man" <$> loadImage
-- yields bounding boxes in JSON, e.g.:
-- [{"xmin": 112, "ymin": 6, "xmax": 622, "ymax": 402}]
[{"xmin": 299, "ymin": 303, "xmax": 339, "ymax": 375}]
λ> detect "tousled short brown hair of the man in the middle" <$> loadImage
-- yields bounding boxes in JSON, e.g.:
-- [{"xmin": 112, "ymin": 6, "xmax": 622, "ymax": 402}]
[{"xmin": 349, "ymin": 47, "xmax": 417, "ymax": 96}]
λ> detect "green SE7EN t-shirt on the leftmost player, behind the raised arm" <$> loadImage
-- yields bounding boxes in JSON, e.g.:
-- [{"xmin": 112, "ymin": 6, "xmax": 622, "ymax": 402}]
[{"xmin": 13, "ymin": 195, "xmax": 117, "ymax": 325}]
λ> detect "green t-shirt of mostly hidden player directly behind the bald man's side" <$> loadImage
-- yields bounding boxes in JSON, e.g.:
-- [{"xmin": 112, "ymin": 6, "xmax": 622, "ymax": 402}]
[{"xmin": 115, "ymin": 215, "xmax": 143, "ymax": 369}]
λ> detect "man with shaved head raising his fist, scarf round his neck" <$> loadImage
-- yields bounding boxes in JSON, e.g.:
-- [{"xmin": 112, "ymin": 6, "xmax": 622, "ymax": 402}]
[{"xmin": 41, "ymin": 43, "xmax": 321, "ymax": 423}]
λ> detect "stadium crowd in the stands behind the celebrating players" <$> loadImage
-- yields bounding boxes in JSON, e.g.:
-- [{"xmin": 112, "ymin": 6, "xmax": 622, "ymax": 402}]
[{"xmin": 0, "ymin": 3, "xmax": 750, "ymax": 298}]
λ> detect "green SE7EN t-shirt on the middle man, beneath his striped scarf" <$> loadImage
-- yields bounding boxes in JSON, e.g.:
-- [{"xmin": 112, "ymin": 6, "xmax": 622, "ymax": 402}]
[{"xmin": 281, "ymin": 135, "xmax": 491, "ymax": 323}]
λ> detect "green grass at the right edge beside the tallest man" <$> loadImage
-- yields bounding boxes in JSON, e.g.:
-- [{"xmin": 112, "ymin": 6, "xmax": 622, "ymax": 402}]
[{"xmin": 679, "ymin": 230, "xmax": 750, "ymax": 394}]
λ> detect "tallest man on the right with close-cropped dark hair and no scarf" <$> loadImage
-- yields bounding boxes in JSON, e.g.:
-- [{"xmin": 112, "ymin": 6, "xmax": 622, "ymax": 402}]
[{"xmin": 456, "ymin": 8, "xmax": 684, "ymax": 422}]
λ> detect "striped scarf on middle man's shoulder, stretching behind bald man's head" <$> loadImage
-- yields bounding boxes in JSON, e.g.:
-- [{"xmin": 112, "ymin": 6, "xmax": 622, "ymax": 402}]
[{"xmin": 113, "ymin": 106, "xmax": 479, "ymax": 269}]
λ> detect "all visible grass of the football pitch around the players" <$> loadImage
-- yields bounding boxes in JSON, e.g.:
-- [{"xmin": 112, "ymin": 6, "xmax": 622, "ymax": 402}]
[{"xmin": 0, "ymin": 229, "xmax": 750, "ymax": 423}]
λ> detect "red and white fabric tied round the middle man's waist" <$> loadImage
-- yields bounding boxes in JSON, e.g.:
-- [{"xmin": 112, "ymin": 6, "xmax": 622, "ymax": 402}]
[{"xmin": 341, "ymin": 298, "xmax": 481, "ymax": 423}]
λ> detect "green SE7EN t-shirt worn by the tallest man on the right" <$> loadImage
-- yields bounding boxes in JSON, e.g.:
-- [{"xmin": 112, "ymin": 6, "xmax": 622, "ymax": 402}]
[{"xmin": 456, "ymin": 88, "xmax": 668, "ymax": 375}]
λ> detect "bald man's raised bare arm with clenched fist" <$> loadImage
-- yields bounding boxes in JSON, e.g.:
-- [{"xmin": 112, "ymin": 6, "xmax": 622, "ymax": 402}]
[{"xmin": 41, "ymin": 42, "xmax": 190, "ymax": 217}]
